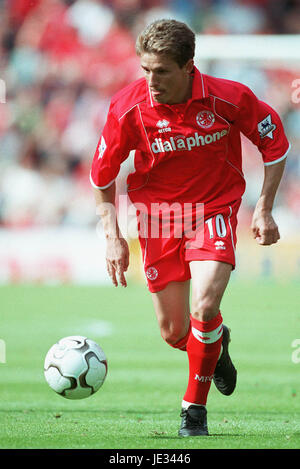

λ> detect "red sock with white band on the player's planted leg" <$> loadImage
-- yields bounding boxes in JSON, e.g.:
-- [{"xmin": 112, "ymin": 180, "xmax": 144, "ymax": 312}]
[{"xmin": 183, "ymin": 312, "xmax": 223, "ymax": 405}]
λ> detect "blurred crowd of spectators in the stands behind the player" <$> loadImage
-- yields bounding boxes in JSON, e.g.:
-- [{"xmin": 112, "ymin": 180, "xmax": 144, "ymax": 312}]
[{"xmin": 0, "ymin": 0, "xmax": 300, "ymax": 234}]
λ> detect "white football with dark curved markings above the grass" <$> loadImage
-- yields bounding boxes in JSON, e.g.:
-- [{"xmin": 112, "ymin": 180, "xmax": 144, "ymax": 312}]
[{"xmin": 44, "ymin": 335, "xmax": 107, "ymax": 399}]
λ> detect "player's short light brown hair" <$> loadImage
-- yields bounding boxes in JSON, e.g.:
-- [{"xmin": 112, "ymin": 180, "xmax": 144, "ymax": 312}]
[{"xmin": 136, "ymin": 20, "xmax": 195, "ymax": 68}]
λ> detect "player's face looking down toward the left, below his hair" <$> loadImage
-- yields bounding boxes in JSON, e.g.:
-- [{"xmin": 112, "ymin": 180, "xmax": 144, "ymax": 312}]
[{"xmin": 141, "ymin": 53, "xmax": 194, "ymax": 104}]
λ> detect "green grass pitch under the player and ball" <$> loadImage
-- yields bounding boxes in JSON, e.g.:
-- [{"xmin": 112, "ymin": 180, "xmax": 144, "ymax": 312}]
[{"xmin": 0, "ymin": 279, "xmax": 300, "ymax": 449}]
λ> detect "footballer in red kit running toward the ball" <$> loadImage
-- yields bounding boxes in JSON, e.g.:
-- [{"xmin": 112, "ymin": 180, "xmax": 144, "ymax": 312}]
[{"xmin": 90, "ymin": 20, "xmax": 290, "ymax": 437}]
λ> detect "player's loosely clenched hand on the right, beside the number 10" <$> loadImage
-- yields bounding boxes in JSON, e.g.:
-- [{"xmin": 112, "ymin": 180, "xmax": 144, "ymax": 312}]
[{"xmin": 251, "ymin": 210, "xmax": 280, "ymax": 246}]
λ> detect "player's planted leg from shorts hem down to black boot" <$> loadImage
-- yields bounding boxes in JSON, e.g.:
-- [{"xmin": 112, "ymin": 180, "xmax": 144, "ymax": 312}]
[{"xmin": 179, "ymin": 261, "xmax": 232, "ymax": 436}]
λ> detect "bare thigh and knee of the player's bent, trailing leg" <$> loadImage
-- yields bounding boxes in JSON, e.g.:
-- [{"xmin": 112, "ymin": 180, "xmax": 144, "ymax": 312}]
[{"xmin": 151, "ymin": 280, "xmax": 190, "ymax": 350}]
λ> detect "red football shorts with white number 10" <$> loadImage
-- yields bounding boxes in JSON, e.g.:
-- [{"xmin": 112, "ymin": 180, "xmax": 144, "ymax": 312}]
[{"xmin": 139, "ymin": 200, "xmax": 241, "ymax": 293}]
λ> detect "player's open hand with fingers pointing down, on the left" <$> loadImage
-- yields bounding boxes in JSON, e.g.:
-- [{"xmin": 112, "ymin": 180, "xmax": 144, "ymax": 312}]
[{"xmin": 106, "ymin": 238, "xmax": 129, "ymax": 287}]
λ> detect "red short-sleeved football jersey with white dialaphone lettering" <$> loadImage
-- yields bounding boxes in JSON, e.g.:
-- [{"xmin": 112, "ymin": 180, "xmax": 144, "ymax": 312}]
[{"xmin": 90, "ymin": 67, "xmax": 289, "ymax": 213}]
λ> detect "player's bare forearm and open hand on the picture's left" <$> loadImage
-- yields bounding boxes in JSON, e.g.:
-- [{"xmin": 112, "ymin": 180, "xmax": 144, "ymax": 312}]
[{"xmin": 94, "ymin": 183, "xmax": 129, "ymax": 287}]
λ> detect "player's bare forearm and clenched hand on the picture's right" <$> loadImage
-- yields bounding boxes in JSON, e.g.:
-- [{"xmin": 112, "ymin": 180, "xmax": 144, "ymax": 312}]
[{"xmin": 251, "ymin": 160, "xmax": 286, "ymax": 246}]
